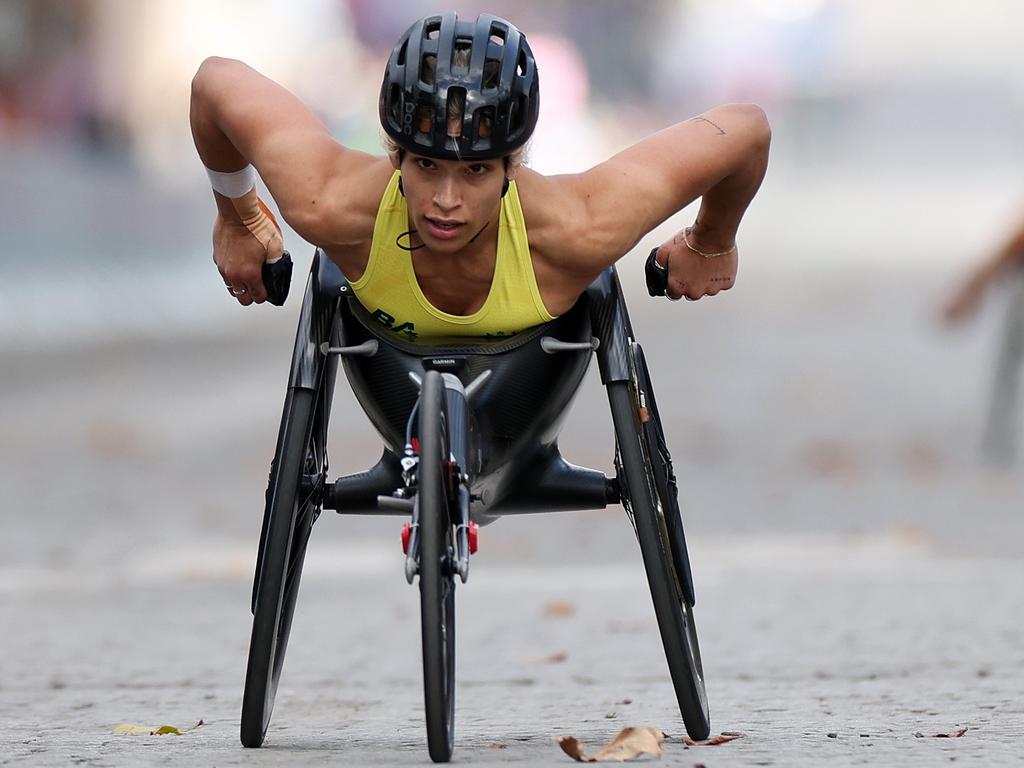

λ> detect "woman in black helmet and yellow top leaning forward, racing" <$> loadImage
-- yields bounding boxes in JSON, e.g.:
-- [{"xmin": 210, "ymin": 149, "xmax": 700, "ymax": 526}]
[{"xmin": 190, "ymin": 12, "xmax": 771, "ymax": 337}]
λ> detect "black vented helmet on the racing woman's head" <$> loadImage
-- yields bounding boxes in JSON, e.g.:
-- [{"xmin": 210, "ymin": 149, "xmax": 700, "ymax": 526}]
[{"xmin": 380, "ymin": 12, "xmax": 541, "ymax": 160}]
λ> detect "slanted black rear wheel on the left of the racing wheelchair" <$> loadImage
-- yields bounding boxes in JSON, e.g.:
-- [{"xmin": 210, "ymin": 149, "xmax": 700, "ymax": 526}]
[{"xmin": 241, "ymin": 388, "xmax": 327, "ymax": 746}]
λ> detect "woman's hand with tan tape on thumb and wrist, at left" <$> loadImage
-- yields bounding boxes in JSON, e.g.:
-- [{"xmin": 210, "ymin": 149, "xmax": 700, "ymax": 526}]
[{"xmin": 213, "ymin": 207, "xmax": 284, "ymax": 306}]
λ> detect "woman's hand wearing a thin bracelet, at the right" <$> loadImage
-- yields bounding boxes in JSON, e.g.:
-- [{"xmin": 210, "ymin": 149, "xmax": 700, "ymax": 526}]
[{"xmin": 654, "ymin": 229, "xmax": 739, "ymax": 301}]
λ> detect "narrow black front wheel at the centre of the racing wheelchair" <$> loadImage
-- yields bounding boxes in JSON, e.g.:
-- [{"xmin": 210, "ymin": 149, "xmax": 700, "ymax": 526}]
[{"xmin": 416, "ymin": 371, "xmax": 455, "ymax": 763}]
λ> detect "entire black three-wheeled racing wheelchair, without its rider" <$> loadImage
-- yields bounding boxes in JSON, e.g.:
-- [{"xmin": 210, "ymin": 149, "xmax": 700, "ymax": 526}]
[{"xmin": 241, "ymin": 250, "xmax": 711, "ymax": 762}]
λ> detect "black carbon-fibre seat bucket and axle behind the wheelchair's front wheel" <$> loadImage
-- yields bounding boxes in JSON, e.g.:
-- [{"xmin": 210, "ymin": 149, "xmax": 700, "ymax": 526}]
[{"xmin": 318, "ymin": 249, "xmax": 609, "ymax": 522}]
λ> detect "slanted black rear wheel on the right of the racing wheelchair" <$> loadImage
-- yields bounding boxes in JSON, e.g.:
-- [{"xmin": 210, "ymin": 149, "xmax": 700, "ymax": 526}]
[{"xmin": 608, "ymin": 381, "xmax": 711, "ymax": 739}]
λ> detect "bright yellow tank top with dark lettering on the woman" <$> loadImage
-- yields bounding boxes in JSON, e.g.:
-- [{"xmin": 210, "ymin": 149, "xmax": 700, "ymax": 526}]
[{"xmin": 351, "ymin": 171, "xmax": 554, "ymax": 339}]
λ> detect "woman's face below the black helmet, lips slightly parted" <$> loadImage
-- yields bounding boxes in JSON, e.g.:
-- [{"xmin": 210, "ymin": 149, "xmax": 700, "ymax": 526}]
[{"xmin": 401, "ymin": 154, "xmax": 505, "ymax": 253}]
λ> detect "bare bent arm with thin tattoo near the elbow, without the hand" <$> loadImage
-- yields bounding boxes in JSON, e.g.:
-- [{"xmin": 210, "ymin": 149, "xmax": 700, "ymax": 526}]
[{"xmin": 553, "ymin": 104, "xmax": 771, "ymax": 273}]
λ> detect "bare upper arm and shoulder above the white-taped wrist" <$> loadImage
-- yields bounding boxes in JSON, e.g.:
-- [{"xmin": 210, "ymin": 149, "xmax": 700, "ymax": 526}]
[{"xmin": 189, "ymin": 57, "xmax": 381, "ymax": 246}]
